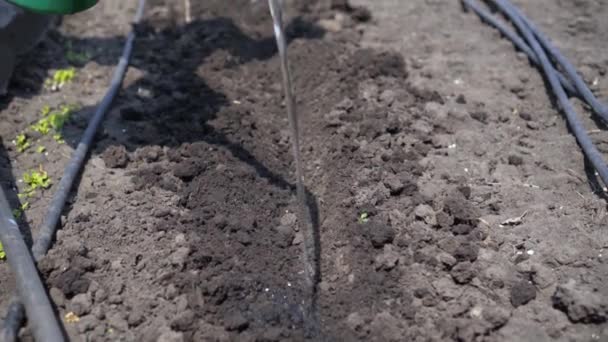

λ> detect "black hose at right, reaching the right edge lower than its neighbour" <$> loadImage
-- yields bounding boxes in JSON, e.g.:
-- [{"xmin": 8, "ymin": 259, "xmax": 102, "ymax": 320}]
[{"xmin": 480, "ymin": 0, "xmax": 608, "ymax": 185}]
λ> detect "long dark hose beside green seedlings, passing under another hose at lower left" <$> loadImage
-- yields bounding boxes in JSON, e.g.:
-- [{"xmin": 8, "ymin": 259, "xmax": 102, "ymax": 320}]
[{"xmin": 2, "ymin": 0, "xmax": 146, "ymax": 342}]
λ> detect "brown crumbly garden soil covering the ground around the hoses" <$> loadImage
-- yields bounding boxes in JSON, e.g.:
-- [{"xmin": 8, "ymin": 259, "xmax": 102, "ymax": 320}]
[{"xmin": 0, "ymin": 0, "xmax": 608, "ymax": 342}]
